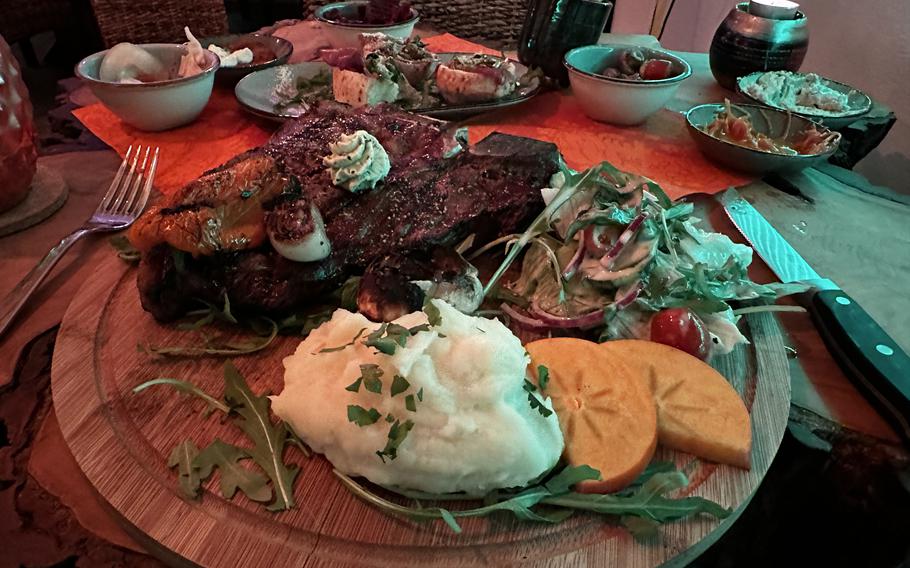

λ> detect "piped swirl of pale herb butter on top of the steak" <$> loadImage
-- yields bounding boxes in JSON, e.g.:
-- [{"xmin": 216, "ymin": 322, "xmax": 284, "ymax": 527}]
[{"xmin": 322, "ymin": 130, "xmax": 392, "ymax": 192}]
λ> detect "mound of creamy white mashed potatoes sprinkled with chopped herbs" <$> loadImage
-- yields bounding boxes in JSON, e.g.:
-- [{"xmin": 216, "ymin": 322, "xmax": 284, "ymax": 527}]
[{"xmin": 272, "ymin": 300, "xmax": 563, "ymax": 495}]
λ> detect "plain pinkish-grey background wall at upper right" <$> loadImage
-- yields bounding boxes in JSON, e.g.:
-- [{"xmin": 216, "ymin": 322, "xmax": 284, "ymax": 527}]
[{"xmin": 613, "ymin": 0, "xmax": 910, "ymax": 193}]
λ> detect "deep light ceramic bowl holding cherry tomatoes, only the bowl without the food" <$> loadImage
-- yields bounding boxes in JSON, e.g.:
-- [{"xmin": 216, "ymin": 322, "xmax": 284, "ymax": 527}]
[{"xmin": 564, "ymin": 44, "xmax": 692, "ymax": 126}]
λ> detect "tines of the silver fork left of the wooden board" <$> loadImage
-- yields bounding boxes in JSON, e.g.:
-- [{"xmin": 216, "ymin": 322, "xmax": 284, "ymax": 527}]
[{"xmin": 95, "ymin": 145, "xmax": 159, "ymax": 218}]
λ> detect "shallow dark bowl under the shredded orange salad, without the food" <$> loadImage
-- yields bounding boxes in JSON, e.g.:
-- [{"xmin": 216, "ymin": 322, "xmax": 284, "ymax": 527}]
[{"xmin": 686, "ymin": 104, "xmax": 840, "ymax": 175}]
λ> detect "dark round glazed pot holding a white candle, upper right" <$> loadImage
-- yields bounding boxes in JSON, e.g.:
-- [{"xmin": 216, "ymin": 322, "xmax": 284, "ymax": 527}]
[{"xmin": 710, "ymin": 2, "xmax": 809, "ymax": 90}]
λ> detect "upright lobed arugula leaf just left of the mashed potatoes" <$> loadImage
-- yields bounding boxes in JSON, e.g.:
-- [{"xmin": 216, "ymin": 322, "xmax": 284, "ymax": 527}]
[{"xmin": 224, "ymin": 361, "xmax": 300, "ymax": 511}]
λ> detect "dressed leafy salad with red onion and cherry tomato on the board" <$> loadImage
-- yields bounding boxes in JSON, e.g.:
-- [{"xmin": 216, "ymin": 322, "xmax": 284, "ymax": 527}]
[{"xmin": 484, "ymin": 158, "xmax": 805, "ymax": 359}]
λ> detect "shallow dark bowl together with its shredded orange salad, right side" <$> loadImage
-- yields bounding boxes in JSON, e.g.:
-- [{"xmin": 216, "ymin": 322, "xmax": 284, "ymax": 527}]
[{"xmin": 686, "ymin": 100, "xmax": 841, "ymax": 175}]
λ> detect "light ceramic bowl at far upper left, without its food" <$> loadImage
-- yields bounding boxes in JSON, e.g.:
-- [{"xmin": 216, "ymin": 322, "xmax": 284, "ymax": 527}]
[{"xmin": 76, "ymin": 43, "xmax": 219, "ymax": 132}]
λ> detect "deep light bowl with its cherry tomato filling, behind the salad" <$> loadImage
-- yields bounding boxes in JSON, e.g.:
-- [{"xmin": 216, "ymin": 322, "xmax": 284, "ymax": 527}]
[{"xmin": 563, "ymin": 44, "xmax": 692, "ymax": 126}]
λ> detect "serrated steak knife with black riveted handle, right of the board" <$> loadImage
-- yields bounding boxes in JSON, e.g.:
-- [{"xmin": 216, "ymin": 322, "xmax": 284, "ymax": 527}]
[{"xmin": 719, "ymin": 188, "xmax": 910, "ymax": 445}]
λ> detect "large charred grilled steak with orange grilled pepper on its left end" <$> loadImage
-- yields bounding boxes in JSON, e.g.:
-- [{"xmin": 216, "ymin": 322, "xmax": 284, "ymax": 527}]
[{"xmin": 129, "ymin": 103, "xmax": 559, "ymax": 321}]
